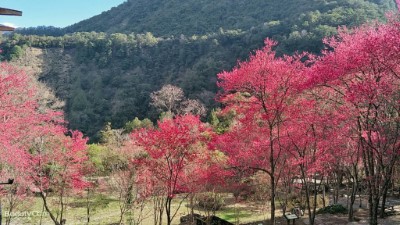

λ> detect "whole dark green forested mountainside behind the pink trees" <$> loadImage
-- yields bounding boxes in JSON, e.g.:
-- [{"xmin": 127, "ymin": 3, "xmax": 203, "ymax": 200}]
[{"xmin": 1, "ymin": 0, "xmax": 394, "ymax": 140}]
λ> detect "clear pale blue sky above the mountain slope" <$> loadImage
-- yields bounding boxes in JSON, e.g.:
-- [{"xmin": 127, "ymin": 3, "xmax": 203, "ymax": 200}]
[{"xmin": 0, "ymin": 0, "xmax": 125, "ymax": 27}]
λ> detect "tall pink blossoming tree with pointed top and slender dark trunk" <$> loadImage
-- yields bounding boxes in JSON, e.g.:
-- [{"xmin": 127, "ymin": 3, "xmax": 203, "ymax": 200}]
[{"xmin": 218, "ymin": 39, "xmax": 304, "ymax": 223}]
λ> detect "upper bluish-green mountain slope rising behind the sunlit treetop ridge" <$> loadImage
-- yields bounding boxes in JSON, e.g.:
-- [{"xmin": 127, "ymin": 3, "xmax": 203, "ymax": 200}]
[{"xmin": 65, "ymin": 0, "xmax": 394, "ymax": 36}]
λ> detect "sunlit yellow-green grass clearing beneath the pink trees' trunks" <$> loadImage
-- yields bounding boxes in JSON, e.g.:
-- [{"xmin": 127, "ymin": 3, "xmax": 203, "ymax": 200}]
[{"xmin": 3, "ymin": 195, "xmax": 272, "ymax": 225}]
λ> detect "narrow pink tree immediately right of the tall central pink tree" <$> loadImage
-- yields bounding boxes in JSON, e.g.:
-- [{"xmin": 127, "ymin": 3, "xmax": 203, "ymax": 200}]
[{"xmin": 286, "ymin": 96, "xmax": 342, "ymax": 224}]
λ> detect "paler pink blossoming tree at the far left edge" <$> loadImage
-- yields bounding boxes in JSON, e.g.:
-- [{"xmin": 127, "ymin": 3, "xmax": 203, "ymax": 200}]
[{"xmin": 0, "ymin": 60, "xmax": 87, "ymax": 224}]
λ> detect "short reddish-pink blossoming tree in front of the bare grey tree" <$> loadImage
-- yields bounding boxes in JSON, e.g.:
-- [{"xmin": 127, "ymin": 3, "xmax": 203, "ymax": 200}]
[{"xmin": 132, "ymin": 115, "xmax": 208, "ymax": 225}]
